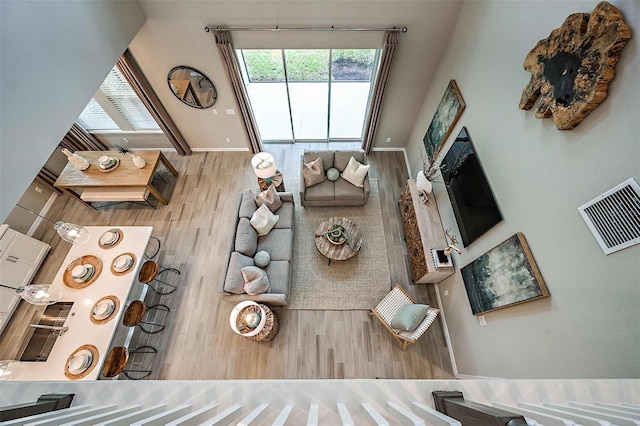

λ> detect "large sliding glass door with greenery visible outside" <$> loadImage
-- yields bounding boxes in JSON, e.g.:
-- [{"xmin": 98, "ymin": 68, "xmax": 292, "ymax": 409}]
[{"xmin": 237, "ymin": 49, "xmax": 379, "ymax": 143}]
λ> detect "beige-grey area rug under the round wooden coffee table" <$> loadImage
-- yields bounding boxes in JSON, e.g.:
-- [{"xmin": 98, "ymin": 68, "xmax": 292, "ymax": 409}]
[{"xmin": 289, "ymin": 179, "xmax": 391, "ymax": 311}]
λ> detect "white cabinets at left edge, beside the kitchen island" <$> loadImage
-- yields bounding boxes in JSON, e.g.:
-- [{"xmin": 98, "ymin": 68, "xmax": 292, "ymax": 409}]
[{"xmin": 0, "ymin": 225, "xmax": 51, "ymax": 332}]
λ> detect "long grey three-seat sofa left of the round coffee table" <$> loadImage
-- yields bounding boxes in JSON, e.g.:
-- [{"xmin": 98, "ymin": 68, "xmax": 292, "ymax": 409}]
[{"xmin": 222, "ymin": 190, "xmax": 295, "ymax": 306}]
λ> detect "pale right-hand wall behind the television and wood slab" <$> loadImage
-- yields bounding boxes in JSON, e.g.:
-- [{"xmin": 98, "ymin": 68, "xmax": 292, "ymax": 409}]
[{"xmin": 407, "ymin": 1, "xmax": 640, "ymax": 378}]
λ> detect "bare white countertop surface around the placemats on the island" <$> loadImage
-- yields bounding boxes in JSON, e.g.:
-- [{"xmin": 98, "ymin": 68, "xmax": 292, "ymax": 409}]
[{"xmin": 6, "ymin": 226, "xmax": 153, "ymax": 380}]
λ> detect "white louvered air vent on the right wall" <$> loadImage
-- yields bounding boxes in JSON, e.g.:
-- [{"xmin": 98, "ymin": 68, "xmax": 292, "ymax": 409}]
[{"xmin": 578, "ymin": 178, "xmax": 640, "ymax": 254}]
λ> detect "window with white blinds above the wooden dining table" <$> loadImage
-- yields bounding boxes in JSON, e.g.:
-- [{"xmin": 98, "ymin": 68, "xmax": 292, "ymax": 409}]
[{"xmin": 78, "ymin": 67, "xmax": 160, "ymax": 132}]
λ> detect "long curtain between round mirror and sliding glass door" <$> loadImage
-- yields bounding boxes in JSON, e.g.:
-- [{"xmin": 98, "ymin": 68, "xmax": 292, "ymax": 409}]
[{"xmin": 213, "ymin": 30, "xmax": 264, "ymax": 152}]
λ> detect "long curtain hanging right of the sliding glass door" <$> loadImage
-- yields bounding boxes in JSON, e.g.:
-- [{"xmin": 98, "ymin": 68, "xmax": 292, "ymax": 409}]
[{"xmin": 362, "ymin": 31, "xmax": 398, "ymax": 154}]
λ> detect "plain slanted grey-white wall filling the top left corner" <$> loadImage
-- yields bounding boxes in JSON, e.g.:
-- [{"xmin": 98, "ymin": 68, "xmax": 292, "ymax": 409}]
[{"xmin": 0, "ymin": 0, "xmax": 145, "ymax": 218}]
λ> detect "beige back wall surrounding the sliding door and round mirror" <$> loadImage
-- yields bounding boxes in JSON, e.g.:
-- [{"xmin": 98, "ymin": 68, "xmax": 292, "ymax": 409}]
[{"xmin": 130, "ymin": 0, "xmax": 461, "ymax": 149}]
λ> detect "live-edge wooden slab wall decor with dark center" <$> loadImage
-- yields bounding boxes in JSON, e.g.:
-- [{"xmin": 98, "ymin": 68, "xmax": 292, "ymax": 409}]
[{"xmin": 519, "ymin": 1, "xmax": 631, "ymax": 130}]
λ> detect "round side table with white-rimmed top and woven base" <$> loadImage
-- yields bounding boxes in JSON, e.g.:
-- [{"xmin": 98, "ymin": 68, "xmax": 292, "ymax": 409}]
[{"xmin": 229, "ymin": 300, "xmax": 278, "ymax": 342}]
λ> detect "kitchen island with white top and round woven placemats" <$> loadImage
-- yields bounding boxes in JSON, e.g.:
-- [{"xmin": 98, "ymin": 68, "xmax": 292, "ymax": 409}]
[{"xmin": 3, "ymin": 226, "xmax": 153, "ymax": 381}]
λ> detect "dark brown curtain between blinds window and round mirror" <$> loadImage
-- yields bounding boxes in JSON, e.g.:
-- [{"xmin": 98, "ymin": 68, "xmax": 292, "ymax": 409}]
[{"xmin": 116, "ymin": 49, "xmax": 191, "ymax": 155}]
